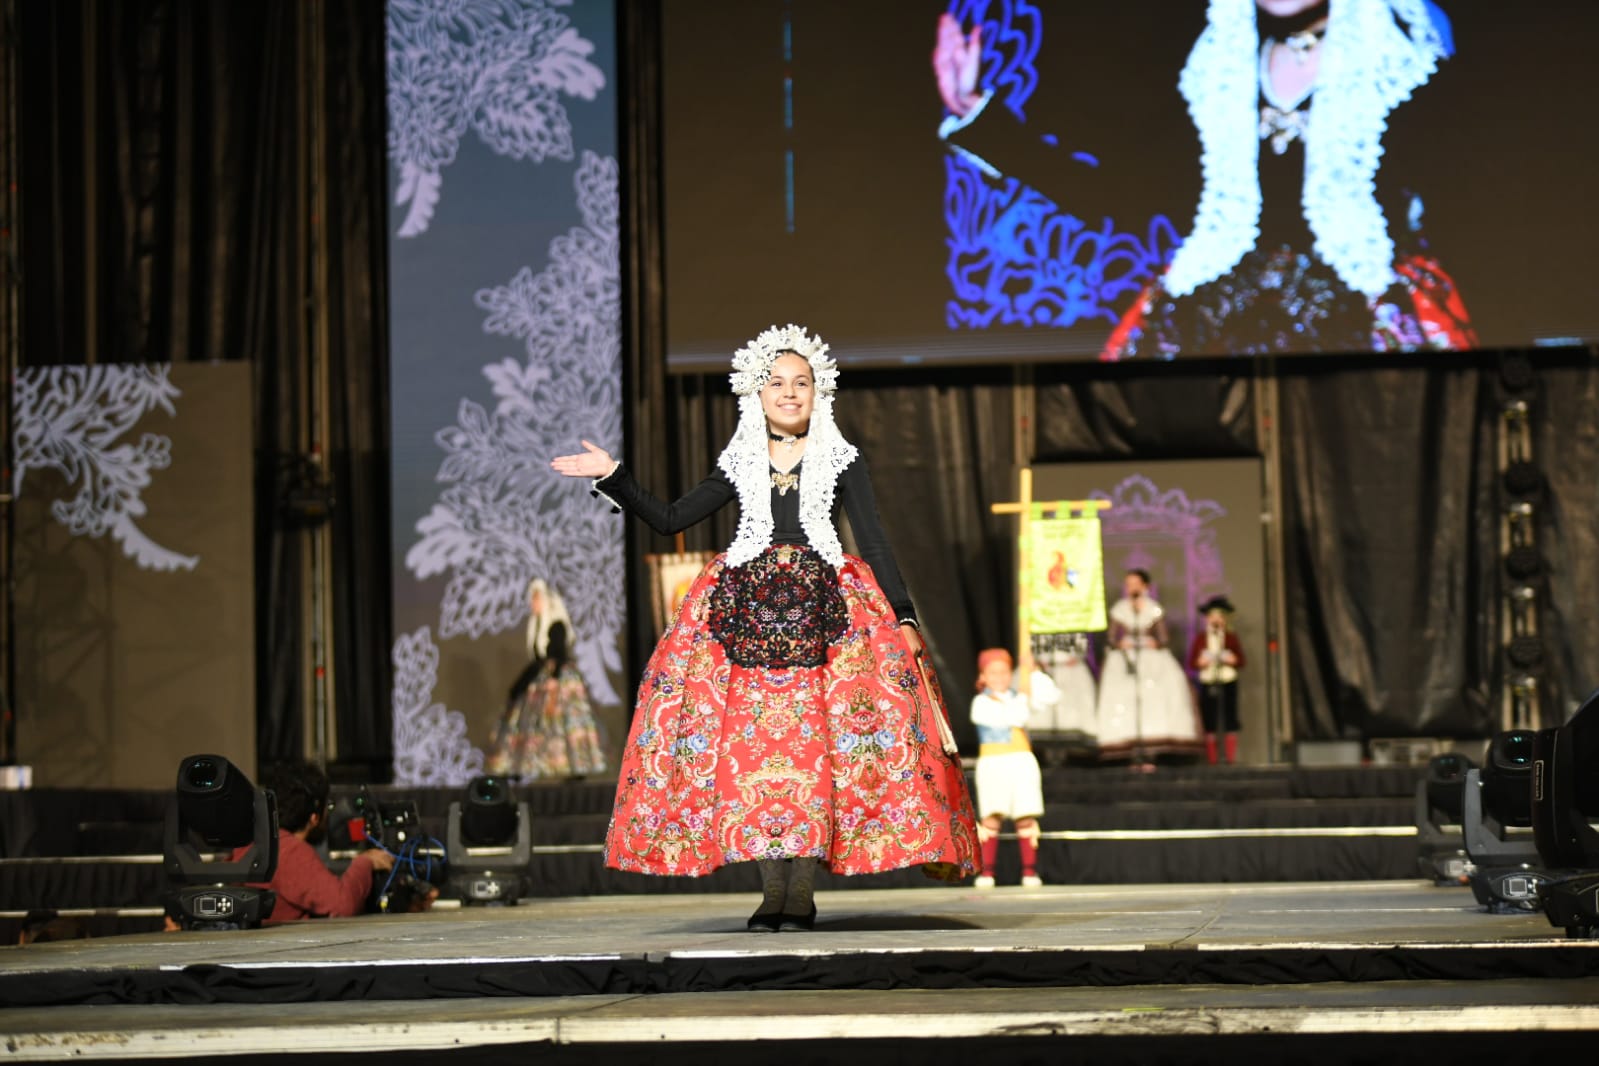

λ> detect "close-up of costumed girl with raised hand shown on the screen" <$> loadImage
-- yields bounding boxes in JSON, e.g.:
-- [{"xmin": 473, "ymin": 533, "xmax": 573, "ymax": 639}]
[{"xmin": 934, "ymin": 0, "xmax": 1477, "ymax": 360}]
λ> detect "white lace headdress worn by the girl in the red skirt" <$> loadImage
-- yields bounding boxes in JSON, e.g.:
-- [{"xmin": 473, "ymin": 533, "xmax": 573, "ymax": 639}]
[{"xmin": 716, "ymin": 324, "xmax": 855, "ymax": 566}]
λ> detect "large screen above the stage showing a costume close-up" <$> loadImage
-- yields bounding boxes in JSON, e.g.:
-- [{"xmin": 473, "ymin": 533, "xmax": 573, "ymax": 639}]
[{"xmin": 662, "ymin": 0, "xmax": 1599, "ymax": 372}]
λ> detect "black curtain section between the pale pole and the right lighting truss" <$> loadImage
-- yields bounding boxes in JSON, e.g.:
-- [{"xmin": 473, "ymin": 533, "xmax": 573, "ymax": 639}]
[{"xmin": 1281, "ymin": 368, "xmax": 1498, "ymax": 738}]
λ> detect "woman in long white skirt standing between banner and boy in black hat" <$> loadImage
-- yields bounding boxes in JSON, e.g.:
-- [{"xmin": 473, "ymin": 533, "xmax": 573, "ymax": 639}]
[{"xmin": 1099, "ymin": 571, "xmax": 1199, "ymax": 758}]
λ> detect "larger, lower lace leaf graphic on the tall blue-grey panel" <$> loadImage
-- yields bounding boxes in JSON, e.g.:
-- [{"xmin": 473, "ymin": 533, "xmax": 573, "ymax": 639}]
[{"xmin": 395, "ymin": 152, "xmax": 624, "ymax": 785}]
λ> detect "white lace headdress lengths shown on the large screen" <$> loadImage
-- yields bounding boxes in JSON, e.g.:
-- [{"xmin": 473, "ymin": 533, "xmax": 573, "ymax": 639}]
[{"xmin": 1164, "ymin": 0, "xmax": 1445, "ymax": 299}]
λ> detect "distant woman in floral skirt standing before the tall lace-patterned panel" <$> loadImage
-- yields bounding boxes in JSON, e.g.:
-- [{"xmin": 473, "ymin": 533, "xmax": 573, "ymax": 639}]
[{"xmin": 484, "ymin": 579, "xmax": 606, "ymax": 780}]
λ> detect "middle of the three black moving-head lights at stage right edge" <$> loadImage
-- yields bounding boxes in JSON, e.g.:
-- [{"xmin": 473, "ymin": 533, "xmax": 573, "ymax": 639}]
[{"xmin": 1461, "ymin": 729, "xmax": 1549, "ymax": 914}]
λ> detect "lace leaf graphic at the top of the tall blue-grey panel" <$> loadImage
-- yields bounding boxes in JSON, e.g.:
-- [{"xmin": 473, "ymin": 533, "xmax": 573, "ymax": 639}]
[{"xmin": 387, "ymin": 0, "xmax": 604, "ymax": 237}]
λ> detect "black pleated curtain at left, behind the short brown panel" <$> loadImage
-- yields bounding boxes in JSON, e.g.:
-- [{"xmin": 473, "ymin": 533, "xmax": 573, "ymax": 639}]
[{"xmin": 19, "ymin": 0, "xmax": 390, "ymax": 772}]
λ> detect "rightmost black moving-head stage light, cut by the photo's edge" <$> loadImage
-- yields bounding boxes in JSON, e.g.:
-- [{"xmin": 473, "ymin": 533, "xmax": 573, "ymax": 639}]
[{"xmin": 1532, "ymin": 692, "xmax": 1599, "ymax": 937}]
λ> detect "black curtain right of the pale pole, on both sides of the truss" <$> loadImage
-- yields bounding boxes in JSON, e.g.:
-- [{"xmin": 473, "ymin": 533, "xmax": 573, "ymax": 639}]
[{"xmin": 1281, "ymin": 355, "xmax": 1599, "ymax": 738}]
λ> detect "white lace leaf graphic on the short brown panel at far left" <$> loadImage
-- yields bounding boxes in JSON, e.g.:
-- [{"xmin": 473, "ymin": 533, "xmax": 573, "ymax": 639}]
[{"xmin": 11, "ymin": 364, "xmax": 200, "ymax": 571}]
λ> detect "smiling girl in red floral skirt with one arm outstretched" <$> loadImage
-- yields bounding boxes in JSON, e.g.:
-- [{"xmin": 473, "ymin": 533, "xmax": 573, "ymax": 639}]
[{"xmin": 553, "ymin": 326, "xmax": 977, "ymax": 932}]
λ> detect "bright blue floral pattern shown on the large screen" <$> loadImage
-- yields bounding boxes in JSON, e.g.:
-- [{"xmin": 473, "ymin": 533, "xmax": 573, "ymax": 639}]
[{"xmin": 943, "ymin": 0, "xmax": 1180, "ymax": 329}]
